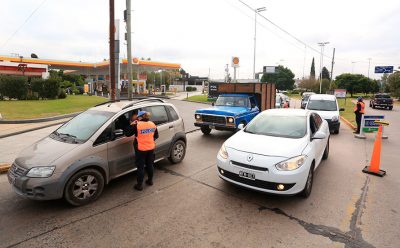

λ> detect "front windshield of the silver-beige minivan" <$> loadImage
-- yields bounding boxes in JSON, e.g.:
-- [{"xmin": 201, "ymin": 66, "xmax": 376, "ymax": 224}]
[{"xmin": 52, "ymin": 110, "xmax": 114, "ymax": 143}]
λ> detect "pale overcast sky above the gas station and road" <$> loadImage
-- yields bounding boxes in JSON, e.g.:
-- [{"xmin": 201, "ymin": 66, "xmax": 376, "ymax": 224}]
[{"xmin": 0, "ymin": 0, "xmax": 400, "ymax": 79}]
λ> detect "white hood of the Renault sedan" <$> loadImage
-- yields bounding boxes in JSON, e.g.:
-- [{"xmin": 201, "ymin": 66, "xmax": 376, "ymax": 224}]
[{"xmin": 225, "ymin": 131, "xmax": 307, "ymax": 158}]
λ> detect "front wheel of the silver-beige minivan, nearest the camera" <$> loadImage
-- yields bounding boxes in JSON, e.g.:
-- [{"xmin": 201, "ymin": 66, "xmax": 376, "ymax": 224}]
[{"xmin": 64, "ymin": 169, "xmax": 104, "ymax": 206}]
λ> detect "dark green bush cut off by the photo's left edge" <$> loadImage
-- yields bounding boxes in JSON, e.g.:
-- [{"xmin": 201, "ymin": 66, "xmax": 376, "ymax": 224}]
[{"xmin": 0, "ymin": 76, "xmax": 28, "ymax": 100}]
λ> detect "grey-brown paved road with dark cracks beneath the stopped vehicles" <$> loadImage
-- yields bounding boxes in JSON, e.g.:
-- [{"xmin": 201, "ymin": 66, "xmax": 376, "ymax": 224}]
[{"xmin": 0, "ymin": 100, "xmax": 400, "ymax": 247}]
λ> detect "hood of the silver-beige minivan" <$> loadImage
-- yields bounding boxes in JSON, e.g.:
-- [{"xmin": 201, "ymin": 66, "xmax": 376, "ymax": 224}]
[{"xmin": 15, "ymin": 137, "xmax": 79, "ymax": 169}]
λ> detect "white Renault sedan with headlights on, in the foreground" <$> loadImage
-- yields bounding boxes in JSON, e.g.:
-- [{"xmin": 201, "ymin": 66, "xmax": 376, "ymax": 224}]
[{"xmin": 217, "ymin": 109, "xmax": 330, "ymax": 197}]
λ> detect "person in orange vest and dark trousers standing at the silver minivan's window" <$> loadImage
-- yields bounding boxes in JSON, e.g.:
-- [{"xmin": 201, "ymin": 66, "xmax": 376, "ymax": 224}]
[{"xmin": 133, "ymin": 111, "xmax": 158, "ymax": 191}]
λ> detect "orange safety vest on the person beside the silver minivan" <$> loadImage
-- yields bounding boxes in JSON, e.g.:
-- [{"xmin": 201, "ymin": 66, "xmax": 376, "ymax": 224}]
[{"xmin": 136, "ymin": 121, "xmax": 157, "ymax": 151}]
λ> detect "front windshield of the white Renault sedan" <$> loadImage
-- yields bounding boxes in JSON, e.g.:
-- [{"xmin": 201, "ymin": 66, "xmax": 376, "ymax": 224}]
[{"xmin": 244, "ymin": 114, "xmax": 307, "ymax": 138}]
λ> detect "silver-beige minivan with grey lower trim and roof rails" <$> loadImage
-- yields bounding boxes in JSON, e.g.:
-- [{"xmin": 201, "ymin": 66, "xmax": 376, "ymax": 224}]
[{"xmin": 8, "ymin": 98, "xmax": 186, "ymax": 206}]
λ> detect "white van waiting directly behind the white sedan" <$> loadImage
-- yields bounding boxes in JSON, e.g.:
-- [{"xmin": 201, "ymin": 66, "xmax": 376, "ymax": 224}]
[{"xmin": 306, "ymin": 94, "xmax": 344, "ymax": 134}]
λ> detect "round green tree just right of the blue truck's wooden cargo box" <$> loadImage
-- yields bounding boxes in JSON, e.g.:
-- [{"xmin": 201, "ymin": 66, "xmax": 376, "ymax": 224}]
[{"xmin": 261, "ymin": 65, "xmax": 294, "ymax": 90}]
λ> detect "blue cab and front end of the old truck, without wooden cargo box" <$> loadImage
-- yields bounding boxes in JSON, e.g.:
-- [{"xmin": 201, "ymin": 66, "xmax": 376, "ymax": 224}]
[{"xmin": 194, "ymin": 94, "xmax": 260, "ymax": 135}]
